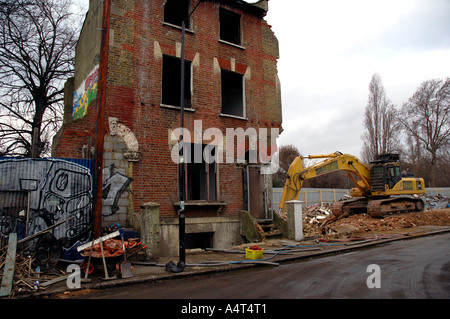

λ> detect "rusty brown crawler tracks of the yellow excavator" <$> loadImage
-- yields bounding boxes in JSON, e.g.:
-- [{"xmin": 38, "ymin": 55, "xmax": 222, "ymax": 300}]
[{"xmin": 331, "ymin": 197, "xmax": 425, "ymax": 218}]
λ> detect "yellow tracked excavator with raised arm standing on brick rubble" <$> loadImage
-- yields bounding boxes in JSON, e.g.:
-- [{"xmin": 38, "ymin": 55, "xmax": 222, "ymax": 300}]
[{"xmin": 279, "ymin": 152, "xmax": 425, "ymax": 217}]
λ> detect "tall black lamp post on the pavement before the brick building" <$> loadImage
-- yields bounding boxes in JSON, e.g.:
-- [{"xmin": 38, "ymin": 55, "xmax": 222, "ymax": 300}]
[{"xmin": 166, "ymin": 0, "xmax": 207, "ymax": 272}]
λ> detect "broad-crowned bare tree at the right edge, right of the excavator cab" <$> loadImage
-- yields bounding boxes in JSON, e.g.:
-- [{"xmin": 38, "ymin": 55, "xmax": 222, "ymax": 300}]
[{"xmin": 398, "ymin": 78, "xmax": 450, "ymax": 187}]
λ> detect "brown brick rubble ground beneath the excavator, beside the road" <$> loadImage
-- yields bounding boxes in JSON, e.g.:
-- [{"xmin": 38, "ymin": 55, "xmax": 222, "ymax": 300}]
[{"xmin": 303, "ymin": 208, "xmax": 450, "ymax": 237}]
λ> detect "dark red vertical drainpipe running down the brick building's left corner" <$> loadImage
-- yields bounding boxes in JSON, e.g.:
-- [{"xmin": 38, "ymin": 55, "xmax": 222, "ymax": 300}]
[{"xmin": 93, "ymin": 0, "xmax": 111, "ymax": 238}]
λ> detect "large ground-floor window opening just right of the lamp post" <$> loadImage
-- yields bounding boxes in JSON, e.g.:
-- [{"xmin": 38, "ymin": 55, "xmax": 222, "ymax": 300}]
[{"xmin": 185, "ymin": 143, "xmax": 216, "ymax": 201}]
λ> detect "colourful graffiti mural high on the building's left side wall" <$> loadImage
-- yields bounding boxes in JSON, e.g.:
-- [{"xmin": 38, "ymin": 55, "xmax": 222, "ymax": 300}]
[{"xmin": 72, "ymin": 65, "xmax": 98, "ymax": 120}]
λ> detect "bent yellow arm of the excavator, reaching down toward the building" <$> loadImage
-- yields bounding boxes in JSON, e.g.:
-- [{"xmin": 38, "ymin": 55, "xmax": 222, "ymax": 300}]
[{"xmin": 279, "ymin": 152, "xmax": 371, "ymax": 214}]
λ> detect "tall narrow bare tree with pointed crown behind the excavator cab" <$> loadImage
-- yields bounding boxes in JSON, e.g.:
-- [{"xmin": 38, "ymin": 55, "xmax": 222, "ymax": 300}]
[{"xmin": 362, "ymin": 74, "xmax": 396, "ymax": 163}]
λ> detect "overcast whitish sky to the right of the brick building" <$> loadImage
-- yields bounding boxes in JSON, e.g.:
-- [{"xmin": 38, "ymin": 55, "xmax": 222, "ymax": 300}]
[{"xmin": 264, "ymin": 0, "xmax": 450, "ymax": 156}]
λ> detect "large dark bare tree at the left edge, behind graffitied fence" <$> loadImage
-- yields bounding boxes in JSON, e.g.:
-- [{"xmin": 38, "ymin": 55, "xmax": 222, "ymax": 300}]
[{"xmin": 0, "ymin": 0, "xmax": 80, "ymax": 157}]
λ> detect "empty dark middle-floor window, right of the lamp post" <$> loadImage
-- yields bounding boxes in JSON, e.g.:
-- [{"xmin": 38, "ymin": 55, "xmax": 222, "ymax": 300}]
[{"xmin": 221, "ymin": 69, "xmax": 245, "ymax": 117}]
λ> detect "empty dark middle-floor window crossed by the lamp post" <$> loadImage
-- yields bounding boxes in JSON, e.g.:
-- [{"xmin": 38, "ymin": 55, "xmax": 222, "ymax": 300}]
[{"xmin": 161, "ymin": 55, "xmax": 191, "ymax": 107}]
